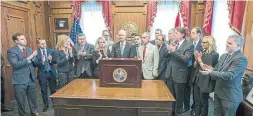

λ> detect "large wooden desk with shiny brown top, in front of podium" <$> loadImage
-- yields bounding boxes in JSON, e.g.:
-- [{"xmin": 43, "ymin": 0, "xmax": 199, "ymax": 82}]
[{"xmin": 50, "ymin": 79, "xmax": 175, "ymax": 116}]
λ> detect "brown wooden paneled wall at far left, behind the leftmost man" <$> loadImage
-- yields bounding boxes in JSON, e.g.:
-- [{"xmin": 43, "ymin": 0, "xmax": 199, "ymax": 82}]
[{"xmin": 1, "ymin": 1, "xmax": 49, "ymax": 103}]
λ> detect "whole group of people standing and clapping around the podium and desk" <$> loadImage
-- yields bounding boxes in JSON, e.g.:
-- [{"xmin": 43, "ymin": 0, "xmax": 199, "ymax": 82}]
[{"xmin": 1, "ymin": 27, "xmax": 247, "ymax": 116}]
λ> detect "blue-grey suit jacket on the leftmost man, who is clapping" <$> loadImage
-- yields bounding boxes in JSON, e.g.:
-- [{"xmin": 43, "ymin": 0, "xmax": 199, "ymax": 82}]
[{"xmin": 7, "ymin": 45, "xmax": 36, "ymax": 84}]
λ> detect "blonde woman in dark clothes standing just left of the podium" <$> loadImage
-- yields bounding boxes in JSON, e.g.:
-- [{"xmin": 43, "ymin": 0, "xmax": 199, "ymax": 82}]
[{"xmin": 92, "ymin": 37, "xmax": 108, "ymax": 77}]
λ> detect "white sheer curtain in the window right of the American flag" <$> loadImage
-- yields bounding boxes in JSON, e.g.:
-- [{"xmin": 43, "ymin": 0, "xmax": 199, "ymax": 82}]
[{"xmin": 80, "ymin": 1, "xmax": 107, "ymax": 45}]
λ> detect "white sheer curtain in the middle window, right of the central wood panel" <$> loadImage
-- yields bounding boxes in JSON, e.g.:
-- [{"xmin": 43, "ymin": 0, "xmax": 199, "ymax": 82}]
[{"xmin": 150, "ymin": 1, "xmax": 179, "ymax": 40}]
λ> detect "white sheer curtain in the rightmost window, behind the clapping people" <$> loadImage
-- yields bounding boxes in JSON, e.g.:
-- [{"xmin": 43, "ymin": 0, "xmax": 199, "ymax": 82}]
[{"xmin": 212, "ymin": 0, "xmax": 236, "ymax": 55}]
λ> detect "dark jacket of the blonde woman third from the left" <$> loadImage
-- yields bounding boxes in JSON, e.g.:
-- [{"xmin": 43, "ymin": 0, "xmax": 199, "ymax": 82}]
[{"xmin": 53, "ymin": 50, "xmax": 74, "ymax": 72}]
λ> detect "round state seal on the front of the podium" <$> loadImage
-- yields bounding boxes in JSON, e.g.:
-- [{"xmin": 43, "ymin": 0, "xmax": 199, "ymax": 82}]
[{"xmin": 113, "ymin": 68, "xmax": 127, "ymax": 82}]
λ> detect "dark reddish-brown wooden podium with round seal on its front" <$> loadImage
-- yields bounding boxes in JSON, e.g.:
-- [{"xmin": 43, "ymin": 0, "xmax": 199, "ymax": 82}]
[{"xmin": 99, "ymin": 58, "xmax": 142, "ymax": 88}]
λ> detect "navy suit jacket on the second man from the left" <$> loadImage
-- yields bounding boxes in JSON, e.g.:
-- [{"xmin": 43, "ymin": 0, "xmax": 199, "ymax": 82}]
[{"xmin": 34, "ymin": 48, "xmax": 57, "ymax": 79}]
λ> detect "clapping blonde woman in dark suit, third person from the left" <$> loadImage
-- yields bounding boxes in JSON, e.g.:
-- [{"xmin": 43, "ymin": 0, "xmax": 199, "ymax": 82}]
[{"xmin": 55, "ymin": 35, "xmax": 74, "ymax": 88}]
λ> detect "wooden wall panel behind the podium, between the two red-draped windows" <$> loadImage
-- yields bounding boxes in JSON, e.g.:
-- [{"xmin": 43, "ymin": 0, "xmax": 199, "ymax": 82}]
[{"xmin": 112, "ymin": 1, "xmax": 147, "ymax": 41}]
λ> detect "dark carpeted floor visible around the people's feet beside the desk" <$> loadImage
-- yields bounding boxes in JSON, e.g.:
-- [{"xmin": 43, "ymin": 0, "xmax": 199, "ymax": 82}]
[{"xmin": 1, "ymin": 89, "xmax": 214, "ymax": 116}]
